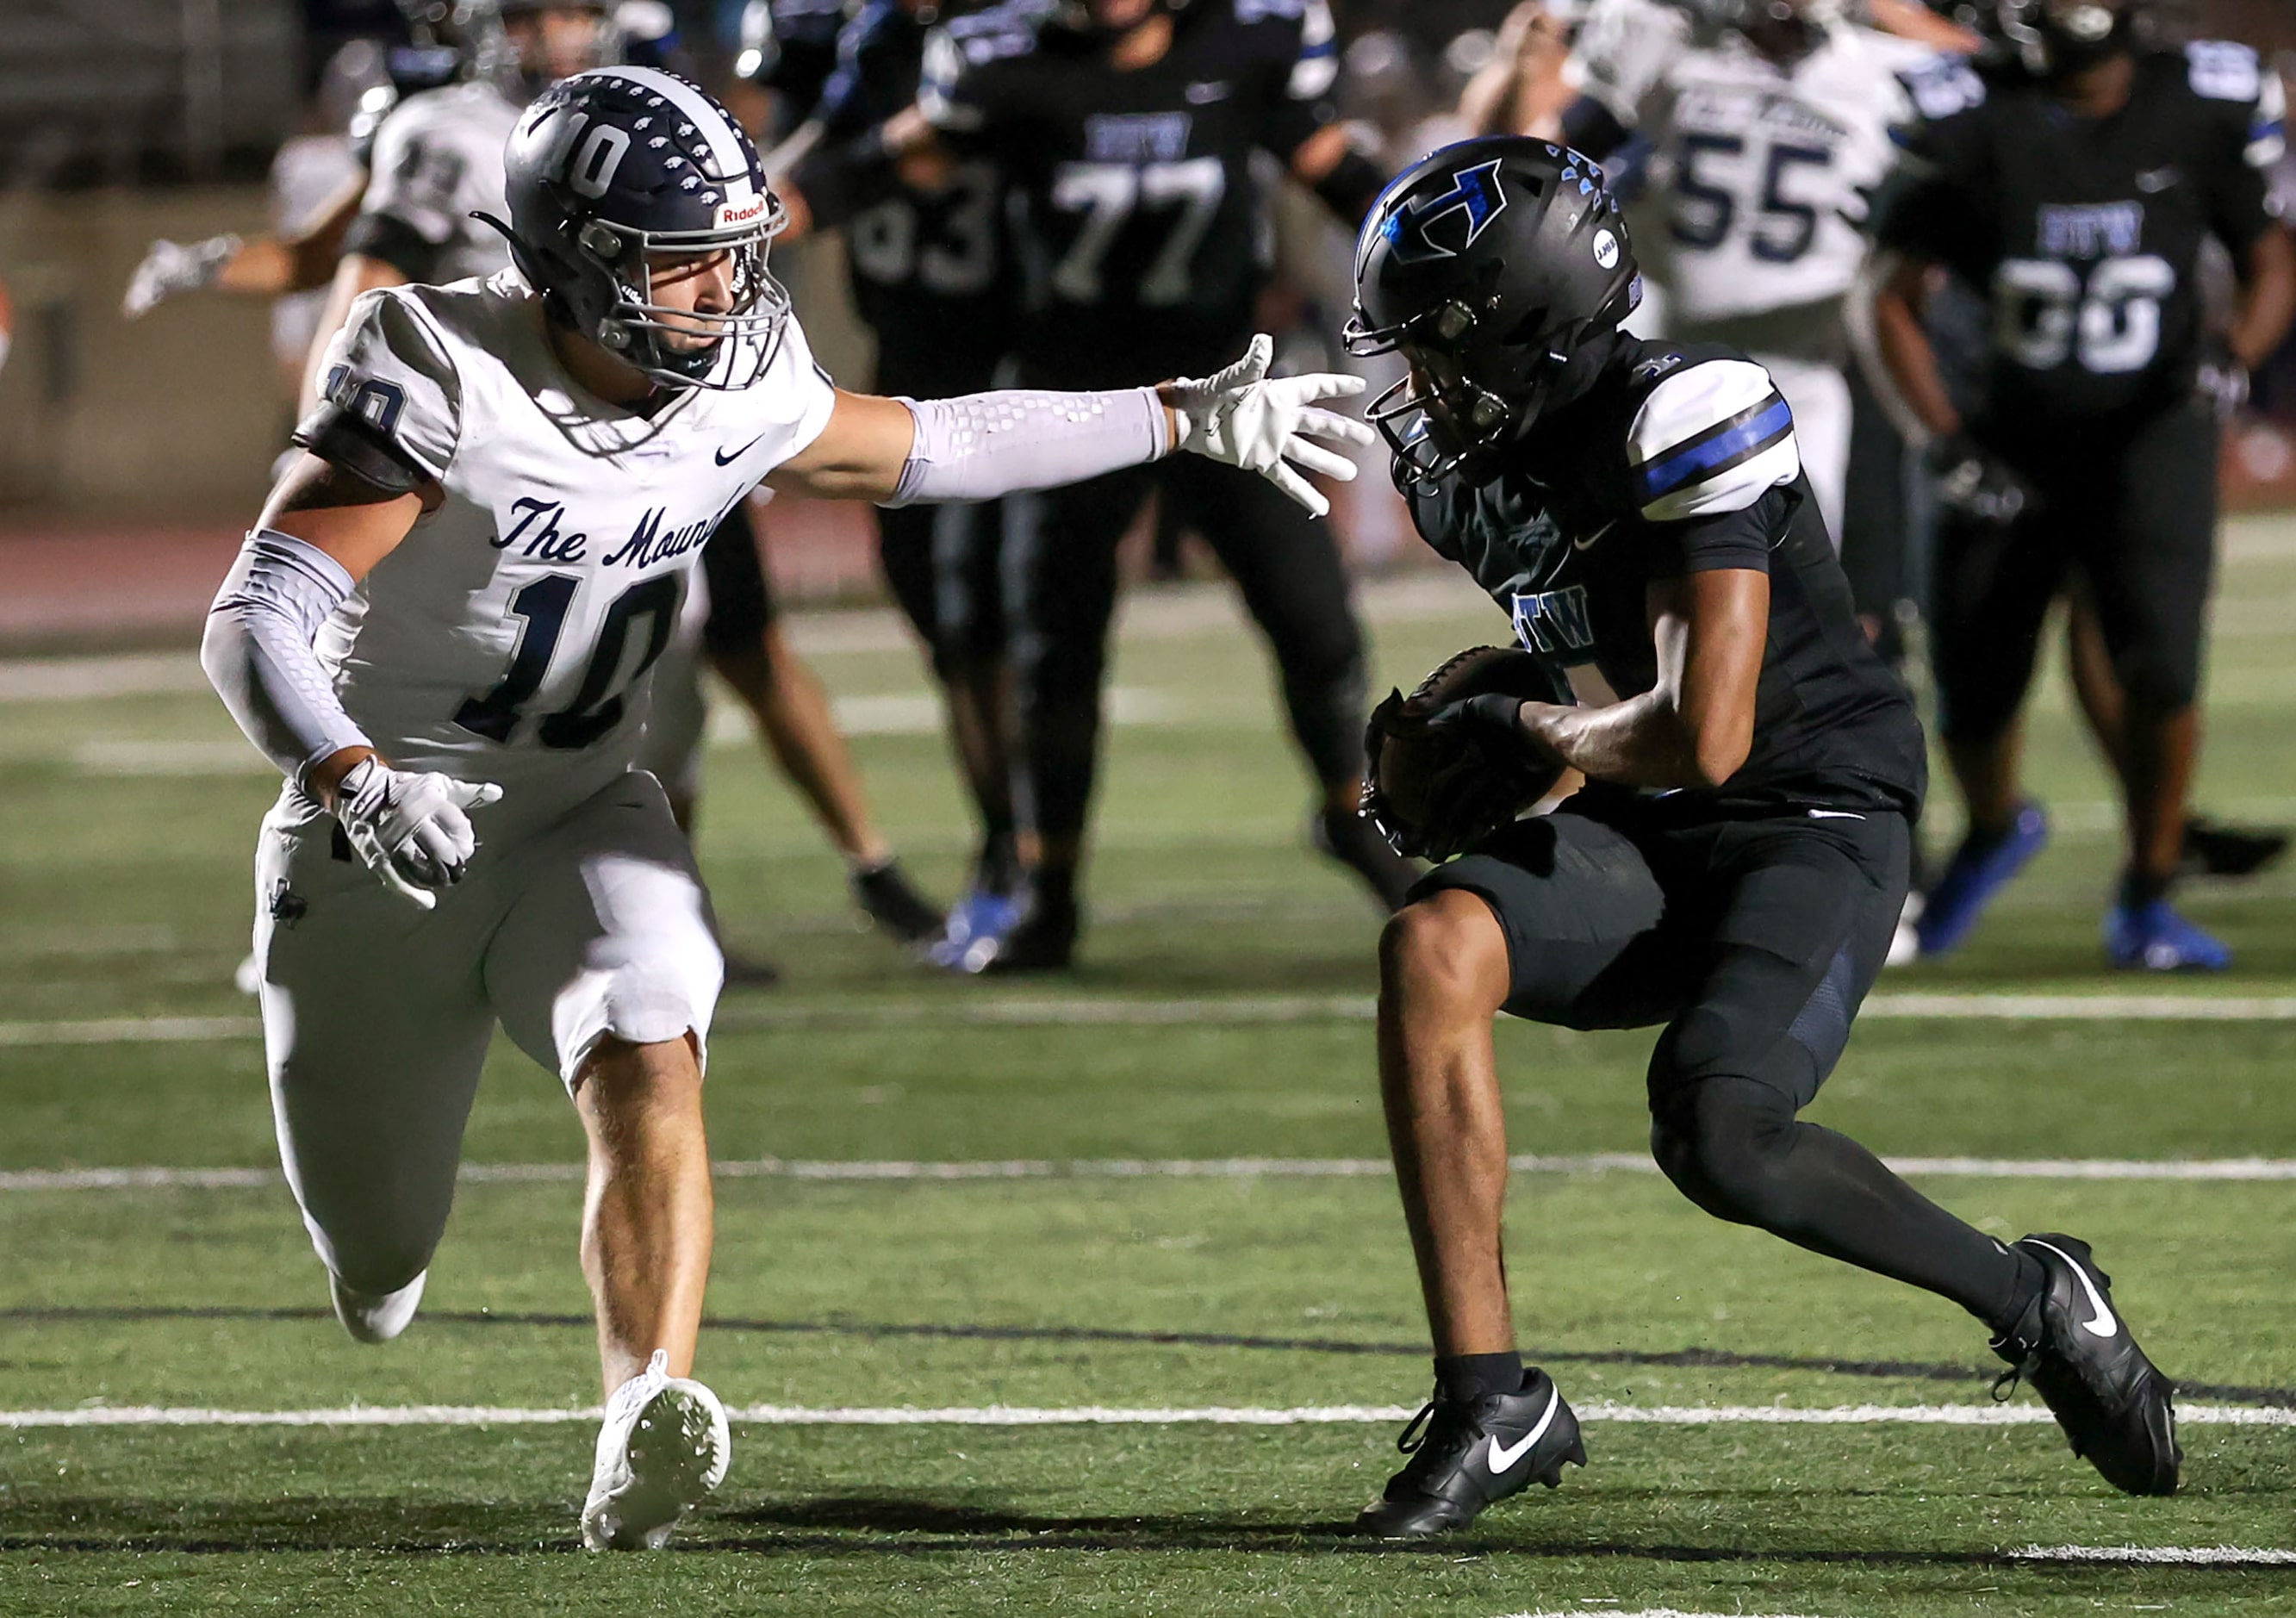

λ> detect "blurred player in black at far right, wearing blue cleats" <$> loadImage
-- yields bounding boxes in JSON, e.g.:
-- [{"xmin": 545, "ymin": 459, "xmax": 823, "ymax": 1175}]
[{"xmin": 1874, "ymin": 0, "xmax": 2296, "ymax": 971}]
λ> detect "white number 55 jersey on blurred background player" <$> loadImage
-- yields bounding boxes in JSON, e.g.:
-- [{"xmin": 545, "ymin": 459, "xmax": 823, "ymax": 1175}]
[{"xmin": 1568, "ymin": 0, "xmax": 1936, "ymax": 333}]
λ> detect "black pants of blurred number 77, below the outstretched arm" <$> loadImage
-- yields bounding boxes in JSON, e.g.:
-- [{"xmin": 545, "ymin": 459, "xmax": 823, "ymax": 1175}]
[{"xmin": 1005, "ymin": 454, "xmax": 1364, "ymax": 843}]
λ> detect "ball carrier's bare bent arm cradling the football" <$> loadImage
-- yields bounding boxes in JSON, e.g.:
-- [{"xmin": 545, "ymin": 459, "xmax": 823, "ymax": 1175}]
[{"xmin": 1522, "ymin": 567, "xmax": 1770, "ymax": 789}]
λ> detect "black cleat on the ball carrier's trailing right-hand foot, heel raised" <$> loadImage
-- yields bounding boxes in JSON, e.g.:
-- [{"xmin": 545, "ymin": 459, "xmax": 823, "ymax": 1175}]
[{"xmin": 1993, "ymin": 1235, "xmax": 2183, "ymax": 1494}]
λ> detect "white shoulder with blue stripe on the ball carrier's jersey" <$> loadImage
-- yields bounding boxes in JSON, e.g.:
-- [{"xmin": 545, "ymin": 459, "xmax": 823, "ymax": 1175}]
[{"xmin": 1626, "ymin": 360, "xmax": 1802, "ymax": 523}]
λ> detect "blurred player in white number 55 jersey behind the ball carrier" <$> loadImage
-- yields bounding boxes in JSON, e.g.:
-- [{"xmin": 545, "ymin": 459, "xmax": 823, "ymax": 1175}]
[{"xmin": 1564, "ymin": 0, "xmax": 1936, "ymax": 544}]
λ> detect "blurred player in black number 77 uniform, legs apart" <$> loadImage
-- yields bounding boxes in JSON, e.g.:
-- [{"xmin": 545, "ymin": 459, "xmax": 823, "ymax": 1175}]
[{"xmin": 797, "ymin": 0, "xmax": 1412, "ymax": 968}]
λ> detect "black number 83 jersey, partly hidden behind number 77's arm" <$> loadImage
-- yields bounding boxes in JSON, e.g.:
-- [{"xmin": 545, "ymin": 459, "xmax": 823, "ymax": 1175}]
[{"xmin": 819, "ymin": 0, "xmax": 1011, "ymax": 386}]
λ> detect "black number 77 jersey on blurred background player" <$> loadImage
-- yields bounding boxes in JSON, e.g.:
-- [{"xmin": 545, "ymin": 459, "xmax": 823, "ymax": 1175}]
[{"xmin": 921, "ymin": 0, "xmax": 1336, "ymax": 386}]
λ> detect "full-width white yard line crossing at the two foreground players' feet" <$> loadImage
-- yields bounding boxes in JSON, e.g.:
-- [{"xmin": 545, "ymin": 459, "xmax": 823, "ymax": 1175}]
[{"xmin": 0, "ymin": 1404, "xmax": 2296, "ymax": 1428}]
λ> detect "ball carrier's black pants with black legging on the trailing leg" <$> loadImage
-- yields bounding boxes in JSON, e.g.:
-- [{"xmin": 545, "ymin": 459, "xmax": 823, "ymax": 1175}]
[{"xmin": 1415, "ymin": 792, "xmax": 2019, "ymax": 1331}]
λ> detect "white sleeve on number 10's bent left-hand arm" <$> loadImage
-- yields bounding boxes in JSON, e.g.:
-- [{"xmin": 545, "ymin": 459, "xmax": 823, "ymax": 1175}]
[{"xmin": 200, "ymin": 528, "xmax": 374, "ymax": 785}]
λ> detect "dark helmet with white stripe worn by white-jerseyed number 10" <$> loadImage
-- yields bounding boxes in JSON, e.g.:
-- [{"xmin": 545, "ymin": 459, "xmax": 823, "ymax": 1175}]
[{"xmin": 482, "ymin": 66, "xmax": 790, "ymax": 390}]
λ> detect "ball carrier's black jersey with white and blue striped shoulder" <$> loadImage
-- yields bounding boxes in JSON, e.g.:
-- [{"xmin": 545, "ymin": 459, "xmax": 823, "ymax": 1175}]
[{"xmin": 1412, "ymin": 335, "xmax": 1926, "ymax": 815}]
